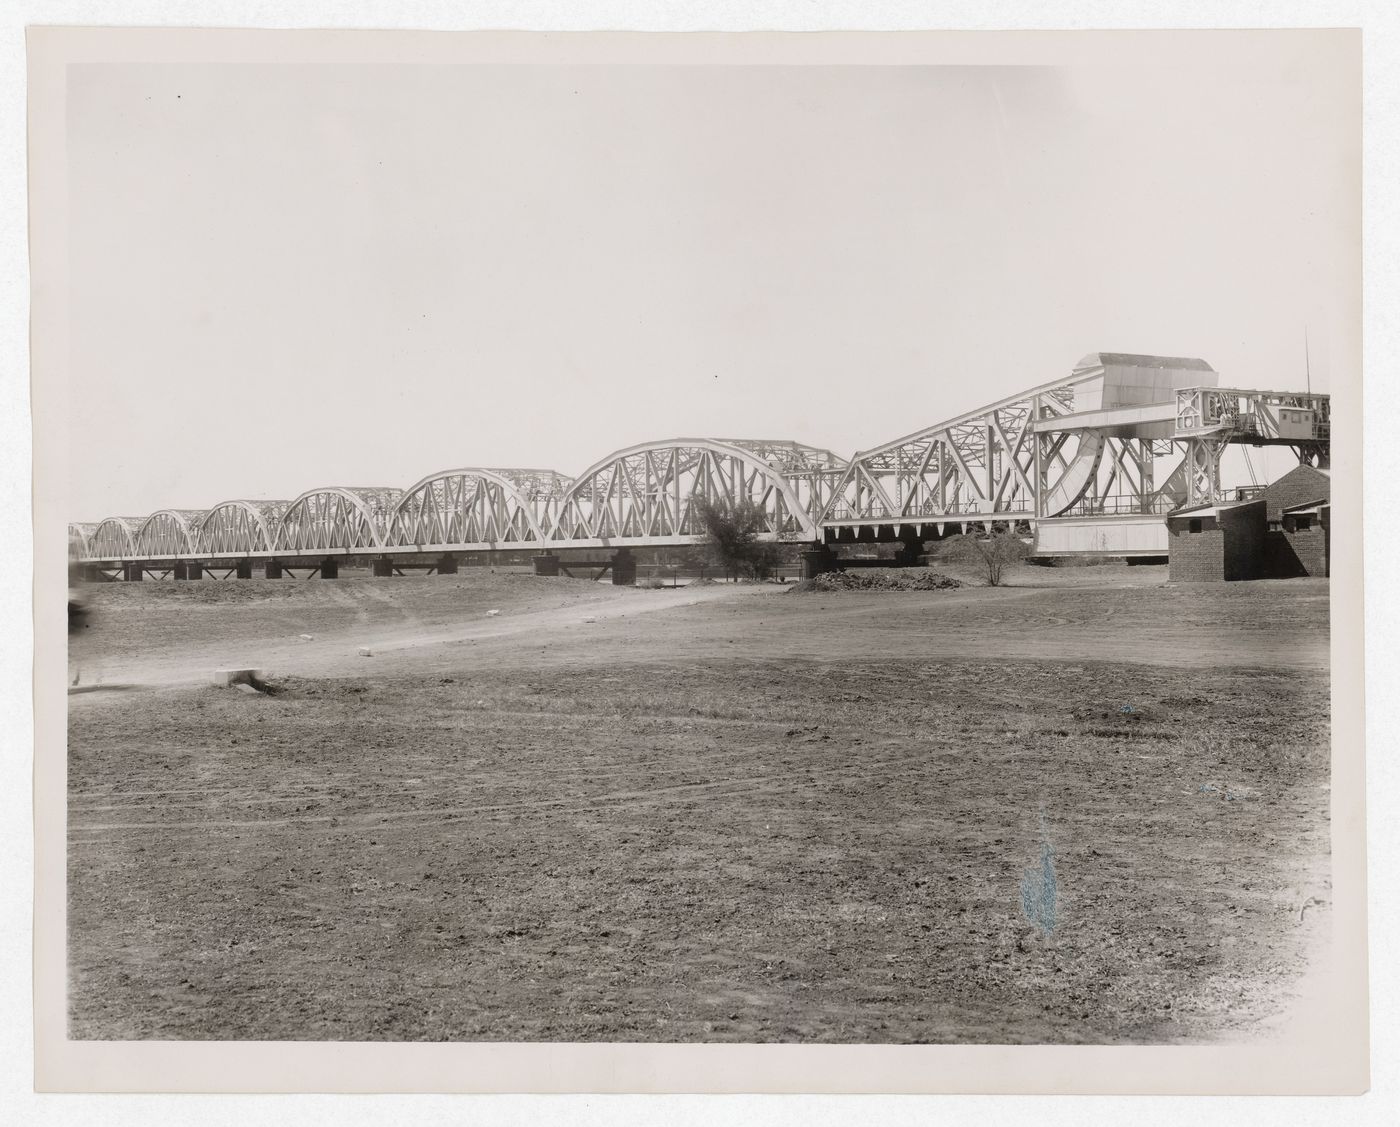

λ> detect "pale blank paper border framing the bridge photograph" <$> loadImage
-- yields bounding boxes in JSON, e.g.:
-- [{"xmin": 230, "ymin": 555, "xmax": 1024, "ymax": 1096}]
[{"xmin": 28, "ymin": 21, "xmax": 1369, "ymax": 1093}]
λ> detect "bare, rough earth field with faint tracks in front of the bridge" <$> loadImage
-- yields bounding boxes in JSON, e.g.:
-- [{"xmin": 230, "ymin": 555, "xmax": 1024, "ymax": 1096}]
[{"xmin": 69, "ymin": 567, "xmax": 1330, "ymax": 1043}]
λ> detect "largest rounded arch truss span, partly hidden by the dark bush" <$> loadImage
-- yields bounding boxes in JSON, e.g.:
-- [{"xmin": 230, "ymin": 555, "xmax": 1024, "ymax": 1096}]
[{"xmin": 549, "ymin": 438, "xmax": 818, "ymax": 547}]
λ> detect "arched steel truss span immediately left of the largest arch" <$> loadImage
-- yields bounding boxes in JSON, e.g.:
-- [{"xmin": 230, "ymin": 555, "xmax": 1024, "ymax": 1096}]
[{"xmin": 385, "ymin": 468, "xmax": 568, "ymax": 552}]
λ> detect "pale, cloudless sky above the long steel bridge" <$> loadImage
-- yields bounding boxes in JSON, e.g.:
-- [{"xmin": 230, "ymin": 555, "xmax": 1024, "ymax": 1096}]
[{"xmin": 67, "ymin": 52, "xmax": 1359, "ymax": 521}]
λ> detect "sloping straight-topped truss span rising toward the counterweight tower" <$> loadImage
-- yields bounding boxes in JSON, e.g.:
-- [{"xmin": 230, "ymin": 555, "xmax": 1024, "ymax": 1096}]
[{"xmin": 820, "ymin": 365, "xmax": 1103, "ymax": 524}]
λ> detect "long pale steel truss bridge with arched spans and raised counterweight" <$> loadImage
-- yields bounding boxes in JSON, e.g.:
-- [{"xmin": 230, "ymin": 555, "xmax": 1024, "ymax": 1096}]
[{"xmin": 69, "ymin": 353, "xmax": 1331, "ymax": 578}]
